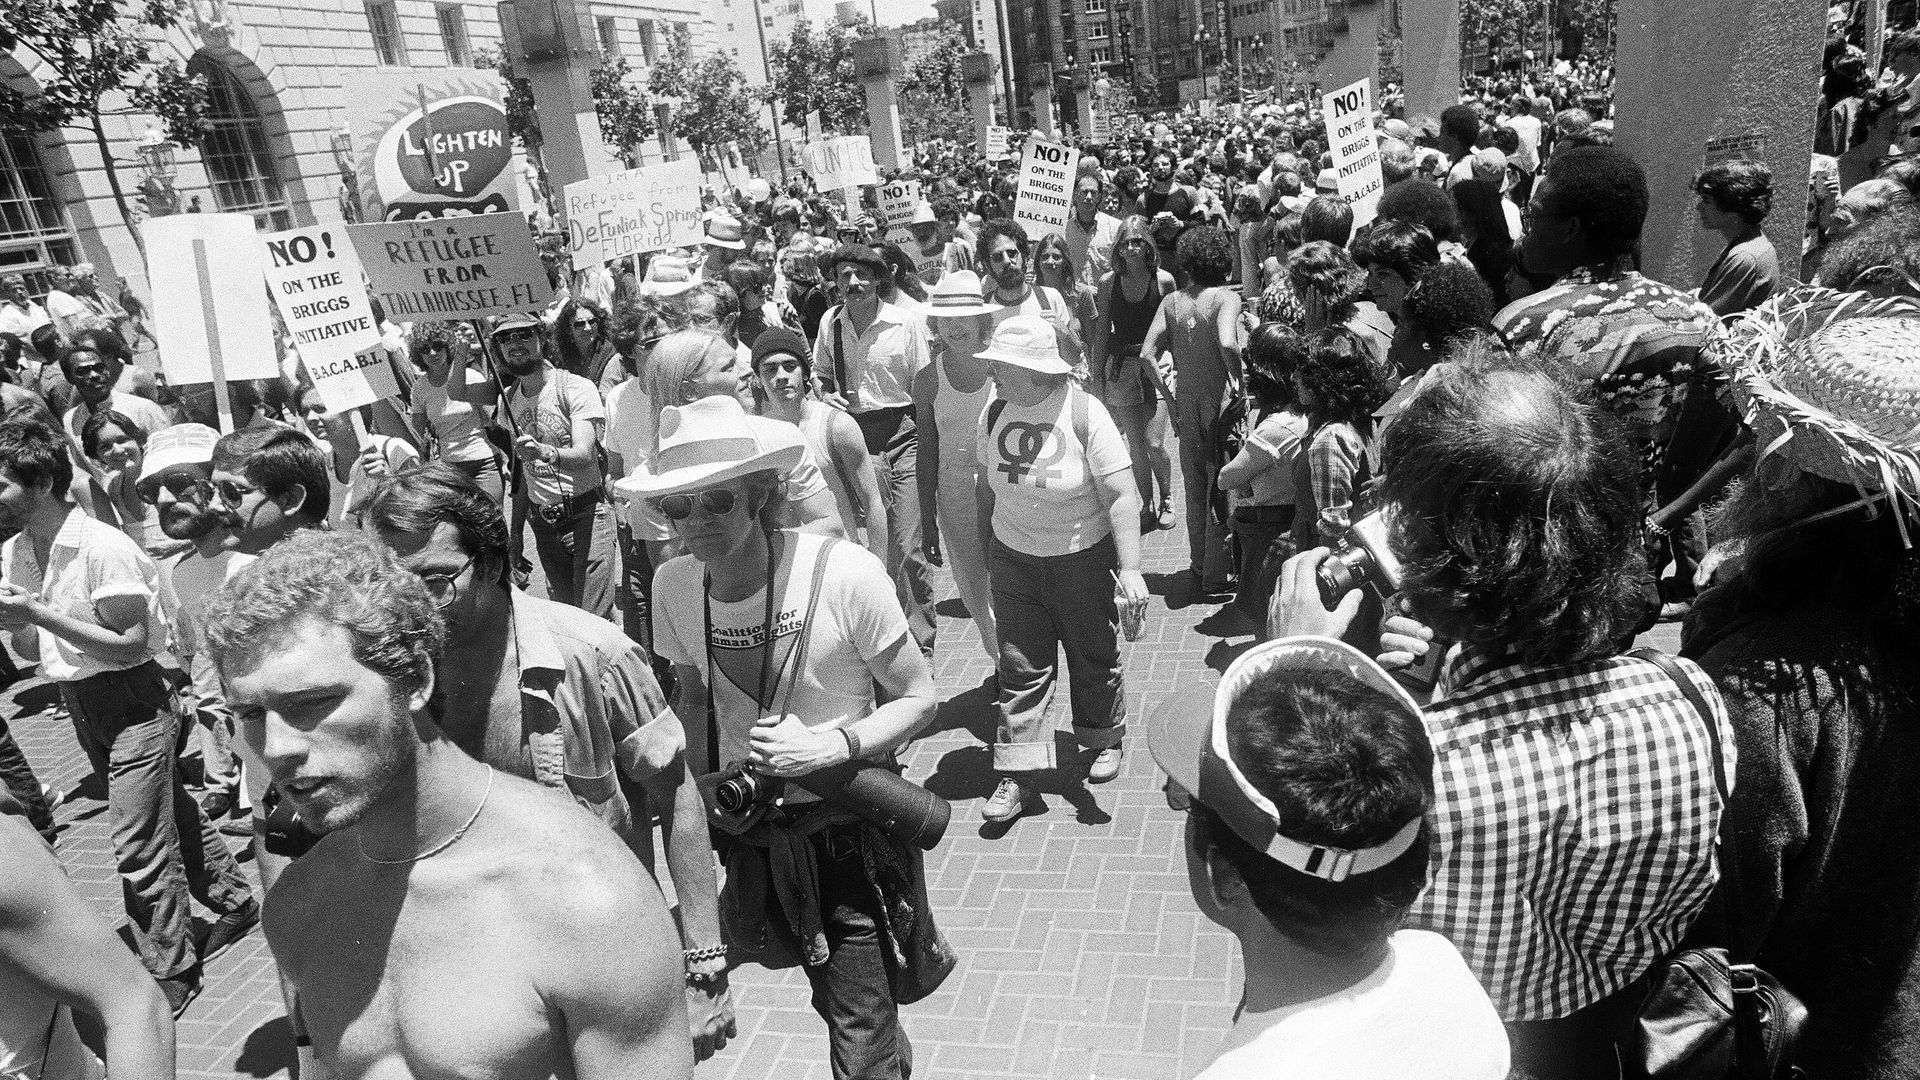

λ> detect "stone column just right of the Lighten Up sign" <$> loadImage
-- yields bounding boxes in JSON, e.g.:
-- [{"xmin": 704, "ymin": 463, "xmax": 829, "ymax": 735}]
[{"xmin": 497, "ymin": 0, "xmax": 626, "ymax": 187}]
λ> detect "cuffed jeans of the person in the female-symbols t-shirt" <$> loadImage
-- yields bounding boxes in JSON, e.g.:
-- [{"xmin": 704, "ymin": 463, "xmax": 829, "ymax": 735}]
[{"xmin": 987, "ymin": 536, "xmax": 1127, "ymax": 773}]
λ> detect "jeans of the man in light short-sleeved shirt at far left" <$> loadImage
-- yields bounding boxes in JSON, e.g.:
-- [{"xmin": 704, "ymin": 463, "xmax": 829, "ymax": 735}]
[{"xmin": 60, "ymin": 661, "xmax": 253, "ymax": 978}]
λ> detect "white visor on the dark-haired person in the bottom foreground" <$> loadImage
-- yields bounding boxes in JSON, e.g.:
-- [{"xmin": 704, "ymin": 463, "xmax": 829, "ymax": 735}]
[{"xmin": 1146, "ymin": 636, "xmax": 1425, "ymax": 882}]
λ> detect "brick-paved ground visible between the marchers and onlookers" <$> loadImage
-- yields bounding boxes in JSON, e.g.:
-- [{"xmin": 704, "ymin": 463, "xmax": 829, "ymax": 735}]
[{"xmin": 4, "ymin": 507, "xmax": 1678, "ymax": 1080}]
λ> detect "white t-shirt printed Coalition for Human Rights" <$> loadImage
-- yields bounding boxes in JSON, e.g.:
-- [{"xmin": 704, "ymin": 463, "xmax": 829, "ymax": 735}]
[{"xmin": 653, "ymin": 530, "xmax": 906, "ymax": 771}]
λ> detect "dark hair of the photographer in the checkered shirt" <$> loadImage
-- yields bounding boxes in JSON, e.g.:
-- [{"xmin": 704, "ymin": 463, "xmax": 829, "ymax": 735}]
[{"xmin": 1377, "ymin": 356, "xmax": 1645, "ymax": 665}]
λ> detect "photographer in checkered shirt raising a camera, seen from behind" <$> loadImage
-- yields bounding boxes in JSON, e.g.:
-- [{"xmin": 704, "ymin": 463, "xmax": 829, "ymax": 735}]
[{"xmin": 1269, "ymin": 357, "xmax": 1734, "ymax": 1078}]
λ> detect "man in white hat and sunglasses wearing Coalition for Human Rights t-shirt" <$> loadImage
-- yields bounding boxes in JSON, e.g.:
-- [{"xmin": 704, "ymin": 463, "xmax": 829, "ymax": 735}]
[{"xmin": 620, "ymin": 396, "xmax": 954, "ymax": 1080}]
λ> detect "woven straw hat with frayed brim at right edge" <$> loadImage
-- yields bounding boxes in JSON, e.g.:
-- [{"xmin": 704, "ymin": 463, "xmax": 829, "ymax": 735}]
[{"xmin": 1707, "ymin": 286, "xmax": 1920, "ymax": 534}]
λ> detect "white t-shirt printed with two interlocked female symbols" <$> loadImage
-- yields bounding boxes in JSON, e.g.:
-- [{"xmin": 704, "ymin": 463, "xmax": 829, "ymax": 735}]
[{"xmin": 973, "ymin": 382, "xmax": 1133, "ymax": 557}]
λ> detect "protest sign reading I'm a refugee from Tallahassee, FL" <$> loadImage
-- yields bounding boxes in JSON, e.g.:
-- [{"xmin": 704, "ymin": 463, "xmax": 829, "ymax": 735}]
[{"xmin": 348, "ymin": 213, "xmax": 553, "ymax": 323}]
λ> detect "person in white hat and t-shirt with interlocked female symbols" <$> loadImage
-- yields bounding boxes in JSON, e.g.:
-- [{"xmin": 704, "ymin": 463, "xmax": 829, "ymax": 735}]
[{"xmin": 973, "ymin": 315, "xmax": 1146, "ymax": 822}]
